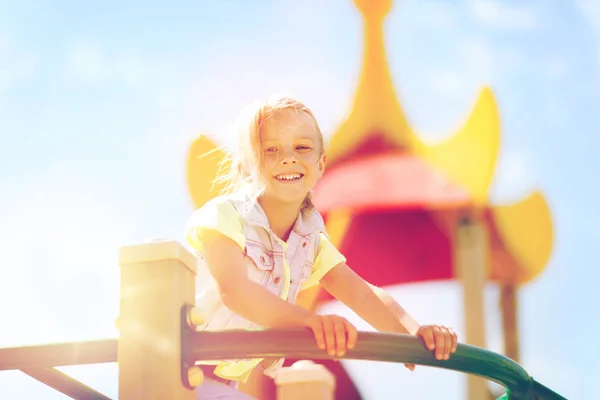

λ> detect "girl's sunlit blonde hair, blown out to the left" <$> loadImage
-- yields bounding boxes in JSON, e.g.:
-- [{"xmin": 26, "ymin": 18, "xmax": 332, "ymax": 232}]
[{"xmin": 217, "ymin": 96, "xmax": 325, "ymax": 209}]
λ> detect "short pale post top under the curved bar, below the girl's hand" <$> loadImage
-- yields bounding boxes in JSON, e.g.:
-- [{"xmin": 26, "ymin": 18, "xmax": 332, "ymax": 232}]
[{"xmin": 275, "ymin": 360, "xmax": 335, "ymax": 400}]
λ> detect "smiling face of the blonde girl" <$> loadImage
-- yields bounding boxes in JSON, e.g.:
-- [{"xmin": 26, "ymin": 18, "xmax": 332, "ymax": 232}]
[{"xmin": 260, "ymin": 109, "xmax": 325, "ymax": 204}]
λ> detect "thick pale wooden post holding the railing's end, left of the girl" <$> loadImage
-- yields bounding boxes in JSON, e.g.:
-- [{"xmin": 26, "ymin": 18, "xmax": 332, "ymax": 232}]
[{"xmin": 118, "ymin": 240, "xmax": 201, "ymax": 400}]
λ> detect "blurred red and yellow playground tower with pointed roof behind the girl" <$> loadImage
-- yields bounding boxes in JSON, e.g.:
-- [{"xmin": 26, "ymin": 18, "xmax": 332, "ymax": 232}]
[{"xmin": 188, "ymin": 0, "xmax": 553, "ymax": 400}]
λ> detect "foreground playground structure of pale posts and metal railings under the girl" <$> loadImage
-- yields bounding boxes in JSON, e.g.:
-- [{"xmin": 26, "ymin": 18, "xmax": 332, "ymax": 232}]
[{"xmin": 0, "ymin": 241, "xmax": 564, "ymax": 400}]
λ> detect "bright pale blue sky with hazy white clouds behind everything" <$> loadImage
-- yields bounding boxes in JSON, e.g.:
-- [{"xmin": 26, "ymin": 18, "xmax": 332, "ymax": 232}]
[{"xmin": 0, "ymin": 0, "xmax": 600, "ymax": 399}]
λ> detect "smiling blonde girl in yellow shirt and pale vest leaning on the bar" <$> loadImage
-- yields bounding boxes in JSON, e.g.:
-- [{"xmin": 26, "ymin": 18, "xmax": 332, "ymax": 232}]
[{"xmin": 186, "ymin": 97, "xmax": 457, "ymax": 399}]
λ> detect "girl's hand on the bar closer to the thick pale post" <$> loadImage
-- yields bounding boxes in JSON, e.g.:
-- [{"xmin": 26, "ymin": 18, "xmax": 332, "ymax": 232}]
[{"xmin": 306, "ymin": 314, "xmax": 358, "ymax": 357}]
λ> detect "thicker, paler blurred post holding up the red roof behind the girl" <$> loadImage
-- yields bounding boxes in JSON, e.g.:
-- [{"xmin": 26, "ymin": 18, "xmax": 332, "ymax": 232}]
[{"xmin": 455, "ymin": 215, "xmax": 489, "ymax": 400}]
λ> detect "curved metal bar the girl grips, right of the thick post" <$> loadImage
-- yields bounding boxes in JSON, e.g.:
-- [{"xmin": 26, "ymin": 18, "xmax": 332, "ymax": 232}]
[{"xmin": 182, "ymin": 329, "xmax": 564, "ymax": 400}]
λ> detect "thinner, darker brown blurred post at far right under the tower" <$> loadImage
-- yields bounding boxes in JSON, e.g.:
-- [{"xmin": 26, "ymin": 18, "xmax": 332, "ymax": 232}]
[{"xmin": 500, "ymin": 282, "xmax": 519, "ymax": 363}]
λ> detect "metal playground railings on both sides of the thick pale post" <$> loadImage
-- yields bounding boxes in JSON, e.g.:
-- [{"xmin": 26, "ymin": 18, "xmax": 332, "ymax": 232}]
[{"xmin": 0, "ymin": 330, "xmax": 564, "ymax": 400}]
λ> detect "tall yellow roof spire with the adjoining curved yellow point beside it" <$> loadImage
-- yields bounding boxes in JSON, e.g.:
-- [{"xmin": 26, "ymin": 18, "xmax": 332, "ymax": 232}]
[{"xmin": 327, "ymin": 0, "xmax": 500, "ymax": 203}]
